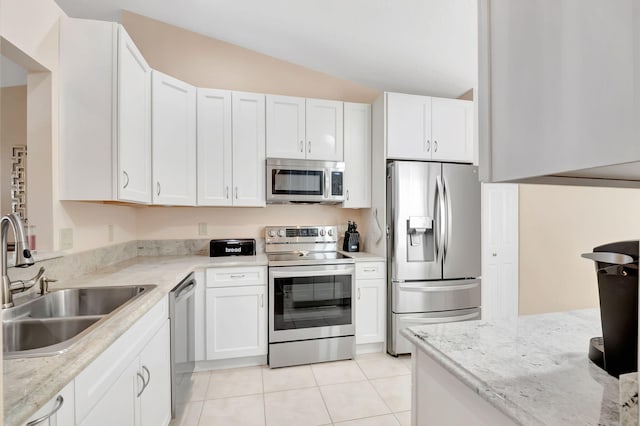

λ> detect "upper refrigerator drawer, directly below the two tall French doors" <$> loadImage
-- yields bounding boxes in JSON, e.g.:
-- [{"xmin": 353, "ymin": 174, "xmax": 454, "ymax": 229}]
[{"xmin": 391, "ymin": 279, "xmax": 481, "ymax": 314}]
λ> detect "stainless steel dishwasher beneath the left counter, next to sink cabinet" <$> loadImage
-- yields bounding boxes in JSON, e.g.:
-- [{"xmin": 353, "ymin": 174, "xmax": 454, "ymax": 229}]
[{"xmin": 169, "ymin": 273, "xmax": 196, "ymax": 418}]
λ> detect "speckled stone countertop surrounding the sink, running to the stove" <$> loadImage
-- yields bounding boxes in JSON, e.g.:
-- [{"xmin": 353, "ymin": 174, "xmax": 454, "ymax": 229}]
[{"xmin": 3, "ymin": 255, "xmax": 267, "ymax": 426}]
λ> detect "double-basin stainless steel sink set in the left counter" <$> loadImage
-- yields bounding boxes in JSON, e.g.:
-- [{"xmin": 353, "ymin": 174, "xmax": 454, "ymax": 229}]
[{"xmin": 2, "ymin": 285, "xmax": 156, "ymax": 359}]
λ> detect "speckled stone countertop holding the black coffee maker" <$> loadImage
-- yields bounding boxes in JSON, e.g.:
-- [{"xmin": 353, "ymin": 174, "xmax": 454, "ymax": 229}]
[{"xmin": 403, "ymin": 309, "xmax": 619, "ymax": 425}]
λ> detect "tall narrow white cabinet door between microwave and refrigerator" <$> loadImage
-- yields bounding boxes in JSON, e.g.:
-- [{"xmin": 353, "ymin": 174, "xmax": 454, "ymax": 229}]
[{"xmin": 342, "ymin": 102, "xmax": 371, "ymax": 208}]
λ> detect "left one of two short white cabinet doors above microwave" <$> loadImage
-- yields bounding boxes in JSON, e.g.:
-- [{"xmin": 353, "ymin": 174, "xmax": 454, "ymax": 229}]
[{"xmin": 267, "ymin": 95, "xmax": 305, "ymax": 158}]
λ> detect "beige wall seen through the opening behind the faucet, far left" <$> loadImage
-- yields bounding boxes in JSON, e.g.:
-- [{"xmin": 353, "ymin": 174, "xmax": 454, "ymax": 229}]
[{"xmin": 0, "ymin": 86, "xmax": 27, "ymax": 215}]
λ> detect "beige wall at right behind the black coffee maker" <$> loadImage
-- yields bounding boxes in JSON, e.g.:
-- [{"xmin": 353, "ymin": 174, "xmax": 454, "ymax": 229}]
[{"xmin": 520, "ymin": 185, "xmax": 640, "ymax": 315}]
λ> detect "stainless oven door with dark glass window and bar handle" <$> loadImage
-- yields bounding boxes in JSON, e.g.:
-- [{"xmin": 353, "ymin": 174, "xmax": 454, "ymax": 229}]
[{"xmin": 269, "ymin": 264, "xmax": 355, "ymax": 343}]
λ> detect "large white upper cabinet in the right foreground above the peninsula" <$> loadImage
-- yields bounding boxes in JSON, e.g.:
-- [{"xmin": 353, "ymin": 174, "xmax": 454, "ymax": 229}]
[{"xmin": 478, "ymin": 0, "xmax": 640, "ymax": 187}]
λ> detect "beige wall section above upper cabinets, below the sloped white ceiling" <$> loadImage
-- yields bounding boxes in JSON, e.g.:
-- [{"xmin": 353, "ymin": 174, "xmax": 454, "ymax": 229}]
[{"xmin": 121, "ymin": 11, "xmax": 380, "ymax": 103}]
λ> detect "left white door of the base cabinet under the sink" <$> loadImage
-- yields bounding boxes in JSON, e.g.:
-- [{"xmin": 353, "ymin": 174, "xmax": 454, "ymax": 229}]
[{"xmin": 80, "ymin": 358, "xmax": 138, "ymax": 426}]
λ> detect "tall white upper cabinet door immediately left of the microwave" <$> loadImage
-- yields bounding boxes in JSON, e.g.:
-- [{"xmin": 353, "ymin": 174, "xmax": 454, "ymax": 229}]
[{"xmin": 231, "ymin": 92, "xmax": 266, "ymax": 207}]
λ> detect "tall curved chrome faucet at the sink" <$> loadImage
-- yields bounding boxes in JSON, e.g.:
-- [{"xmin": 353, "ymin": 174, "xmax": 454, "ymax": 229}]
[{"xmin": 0, "ymin": 213, "xmax": 33, "ymax": 309}]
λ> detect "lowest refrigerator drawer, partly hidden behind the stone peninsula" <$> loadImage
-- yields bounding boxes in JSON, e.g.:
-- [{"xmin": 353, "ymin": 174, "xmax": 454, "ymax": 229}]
[{"xmin": 387, "ymin": 308, "xmax": 481, "ymax": 355}]
